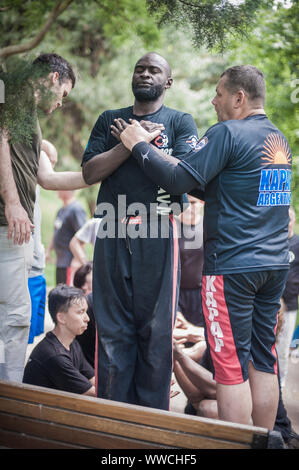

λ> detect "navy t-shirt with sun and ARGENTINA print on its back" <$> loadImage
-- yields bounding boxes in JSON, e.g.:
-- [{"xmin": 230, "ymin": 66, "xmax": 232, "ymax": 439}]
[{"xmin": 179, "ymin": 114, "xmax": 292, "ymax": 274}]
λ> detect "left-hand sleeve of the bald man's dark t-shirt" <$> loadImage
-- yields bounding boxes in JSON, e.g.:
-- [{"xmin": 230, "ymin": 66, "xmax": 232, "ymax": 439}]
[{"xmin": 82, "ymin": 112, "xmax": 110, "ymax": 164}]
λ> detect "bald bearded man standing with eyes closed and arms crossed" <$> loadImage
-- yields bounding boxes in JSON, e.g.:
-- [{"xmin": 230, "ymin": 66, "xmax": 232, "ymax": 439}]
[{"xmin": 82, "ymin": 53, "xmax": 198, "ymax": 410}]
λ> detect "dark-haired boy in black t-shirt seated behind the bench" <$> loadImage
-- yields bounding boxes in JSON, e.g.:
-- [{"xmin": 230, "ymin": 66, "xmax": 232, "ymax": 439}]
[{"xmin": 23, "ymin": 284, "xmax": 96, "ymax": 396}]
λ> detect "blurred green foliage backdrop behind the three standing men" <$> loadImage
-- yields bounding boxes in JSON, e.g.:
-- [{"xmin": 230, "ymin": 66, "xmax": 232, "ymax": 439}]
[{"xmin": 0, "ymin": 0, "xmax": 299, "ymax": 211}]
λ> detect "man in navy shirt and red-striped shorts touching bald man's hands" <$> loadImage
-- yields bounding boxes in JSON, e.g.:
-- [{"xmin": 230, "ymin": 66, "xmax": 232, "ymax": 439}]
[{"xmin": 121, "ymin": 66, "xmax": 291, "ymax": 429}]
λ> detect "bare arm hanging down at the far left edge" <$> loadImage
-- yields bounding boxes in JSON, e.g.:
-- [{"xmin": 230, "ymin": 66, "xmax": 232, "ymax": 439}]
[{"xmin": 0, "ymin": 131, "xmax": 34, "ymax": 245}]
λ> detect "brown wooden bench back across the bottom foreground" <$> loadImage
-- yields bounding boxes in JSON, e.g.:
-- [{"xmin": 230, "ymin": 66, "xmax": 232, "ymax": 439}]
[{"xmin": 0, "ymin": 381, "xmax": 284, "ymax": 449}]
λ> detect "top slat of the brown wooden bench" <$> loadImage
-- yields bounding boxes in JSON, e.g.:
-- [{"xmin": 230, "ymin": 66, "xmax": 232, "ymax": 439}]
[{"xmin": 0, "ymin": 382, "xmax": 267, "ymax": 446}]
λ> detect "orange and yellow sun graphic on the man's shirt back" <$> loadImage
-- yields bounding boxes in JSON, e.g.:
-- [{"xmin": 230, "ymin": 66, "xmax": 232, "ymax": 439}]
[{"xmin": 262, "ymin": 134, "xmax": 291, "ymax": 165}]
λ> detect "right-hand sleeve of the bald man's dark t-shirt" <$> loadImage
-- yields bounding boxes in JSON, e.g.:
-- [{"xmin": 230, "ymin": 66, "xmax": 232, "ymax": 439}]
[{"xmin": 172, "ymin": 114, "xmax": 198, "ymax": 159}]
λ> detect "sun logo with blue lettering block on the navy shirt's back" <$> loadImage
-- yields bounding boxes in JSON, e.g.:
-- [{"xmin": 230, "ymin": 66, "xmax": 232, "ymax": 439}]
[{"xmin": 256, "ymin": 133, "xmax": 291, "ymax": 206}]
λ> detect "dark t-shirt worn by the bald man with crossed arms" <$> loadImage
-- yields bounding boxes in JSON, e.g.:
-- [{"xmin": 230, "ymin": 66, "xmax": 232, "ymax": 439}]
[{"xmin": 82, "ymin": 105, "xmax": 198, "ymax": 216}]
